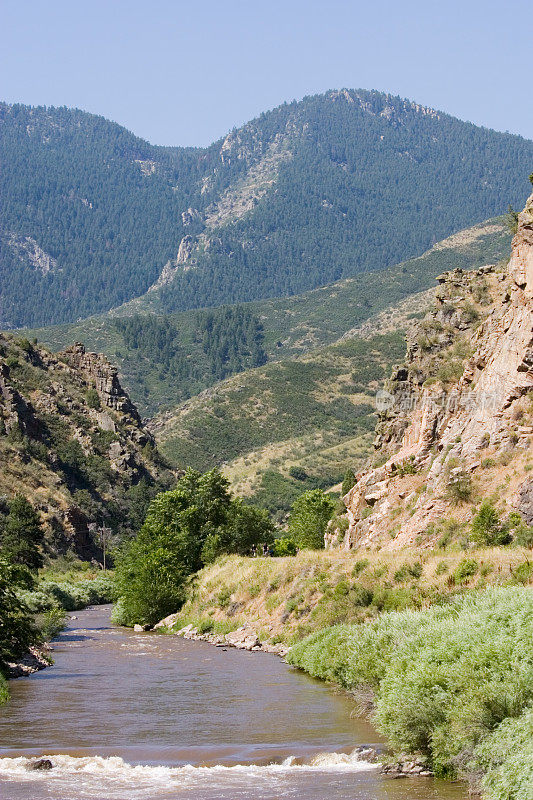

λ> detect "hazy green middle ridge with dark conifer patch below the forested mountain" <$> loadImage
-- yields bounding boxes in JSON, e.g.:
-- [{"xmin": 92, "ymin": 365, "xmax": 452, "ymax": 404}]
[{"xmin": 25, "ymin": 218, "xmax": 511, "ymax": 417}]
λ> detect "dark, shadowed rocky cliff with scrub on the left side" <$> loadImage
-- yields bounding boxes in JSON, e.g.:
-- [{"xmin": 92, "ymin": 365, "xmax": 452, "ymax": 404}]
[{"xmin": 0, "ymin": 334, "xmax": 172, "ymax": 558}]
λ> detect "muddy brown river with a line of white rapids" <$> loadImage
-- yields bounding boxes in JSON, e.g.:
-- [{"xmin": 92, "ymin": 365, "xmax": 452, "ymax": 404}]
[{"xmin": 0, "ymin": 606, "xmax": 466, "ymax": 800}]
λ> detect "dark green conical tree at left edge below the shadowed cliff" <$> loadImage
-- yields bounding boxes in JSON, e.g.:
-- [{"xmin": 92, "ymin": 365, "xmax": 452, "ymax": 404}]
[{"xmin": 0, "ymin": 494, "xmax": 44, "ymax": 570}]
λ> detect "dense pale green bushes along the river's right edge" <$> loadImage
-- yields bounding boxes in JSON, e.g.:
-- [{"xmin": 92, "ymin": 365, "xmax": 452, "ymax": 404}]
[{"xmin": 287, "ymin": 587, "xmax": 533, "ymax": 800}]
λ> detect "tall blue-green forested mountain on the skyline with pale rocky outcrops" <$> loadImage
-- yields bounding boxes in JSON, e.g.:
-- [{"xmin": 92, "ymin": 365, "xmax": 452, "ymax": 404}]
[{"xmin": 0, "ymin": 90, "xmax": 533, "ymax": 328}]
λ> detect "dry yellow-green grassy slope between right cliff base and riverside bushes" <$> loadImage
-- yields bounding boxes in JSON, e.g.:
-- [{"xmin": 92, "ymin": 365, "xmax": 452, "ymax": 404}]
[{"xmin": 167, "ymin": 546, "xmax": 533, "ymax": 644}]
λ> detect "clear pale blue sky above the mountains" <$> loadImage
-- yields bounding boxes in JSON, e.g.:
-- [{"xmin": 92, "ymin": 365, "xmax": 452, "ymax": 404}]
[{"xmin": 0, "ymin": 0, "xmax": 533, "ymax": 145}]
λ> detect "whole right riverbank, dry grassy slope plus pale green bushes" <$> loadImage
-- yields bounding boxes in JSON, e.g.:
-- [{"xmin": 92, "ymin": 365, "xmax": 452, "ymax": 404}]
[{"xmin": 151, "ymin": 564, "xmax": 533, "ymax": 800}]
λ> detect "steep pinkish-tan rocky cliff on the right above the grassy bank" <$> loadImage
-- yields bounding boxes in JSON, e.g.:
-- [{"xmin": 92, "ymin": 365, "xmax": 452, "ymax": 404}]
[{"xmin": 326, "ymin": 195, "xmax": 533, "ymax": 550}]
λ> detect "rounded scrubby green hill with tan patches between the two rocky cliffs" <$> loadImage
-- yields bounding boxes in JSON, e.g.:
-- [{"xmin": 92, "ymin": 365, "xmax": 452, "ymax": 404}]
[{"xmin": 152, "ymin": 330, "xmax": 405, "ymax": 510}]
